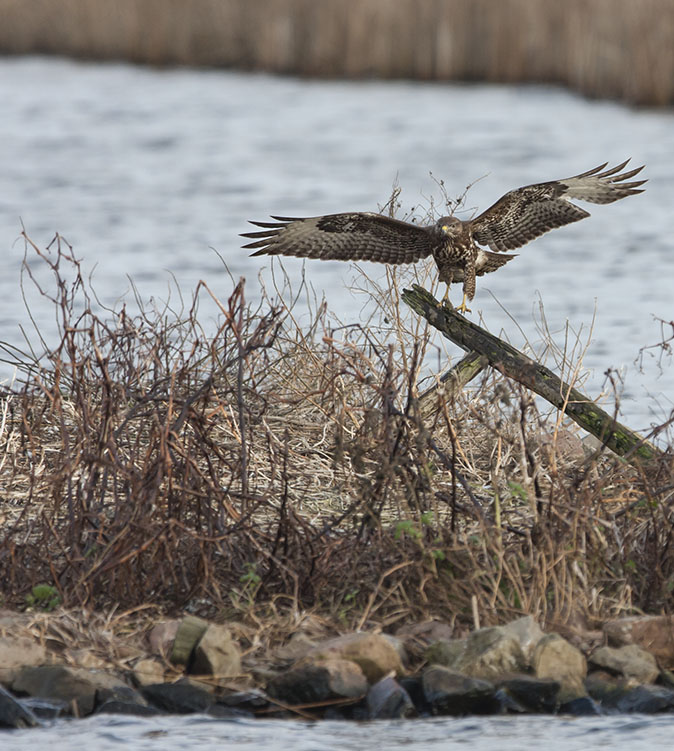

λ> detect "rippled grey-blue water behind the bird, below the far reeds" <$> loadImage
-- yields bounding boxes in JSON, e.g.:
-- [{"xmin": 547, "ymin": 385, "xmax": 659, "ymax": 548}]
[{"xmin": 0, "ymin": 58, "xmax": 674, "ymax": 429}]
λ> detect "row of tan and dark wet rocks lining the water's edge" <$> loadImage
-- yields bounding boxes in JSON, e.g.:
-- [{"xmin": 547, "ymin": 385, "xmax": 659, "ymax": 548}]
[{"xmin": 0, "ymin": 611, "xmax": 674, "ymax": 728}]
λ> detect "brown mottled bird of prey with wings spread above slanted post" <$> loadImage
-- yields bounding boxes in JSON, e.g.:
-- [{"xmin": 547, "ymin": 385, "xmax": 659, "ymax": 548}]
[{"xmin": 242, "ymin": 159, "xmax": 646, "ymax": 313}]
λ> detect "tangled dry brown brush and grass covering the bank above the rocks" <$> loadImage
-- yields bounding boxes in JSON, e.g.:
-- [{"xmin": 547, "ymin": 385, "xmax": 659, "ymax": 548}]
[{"xmin": 0, "ymin": 232, "xmax": 674, "ymax": 627}]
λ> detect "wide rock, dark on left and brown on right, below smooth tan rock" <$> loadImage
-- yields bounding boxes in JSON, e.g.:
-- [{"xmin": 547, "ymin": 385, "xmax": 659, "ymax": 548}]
[{"xmin": 267, "ymin": 658, "xmax": 368, "ymax": 704}]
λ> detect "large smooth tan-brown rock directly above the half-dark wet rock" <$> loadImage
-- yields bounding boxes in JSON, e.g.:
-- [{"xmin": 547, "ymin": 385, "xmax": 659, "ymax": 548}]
[{"xmin": 307, "ymin": 633, "xmax": 403, "ymax": 684}]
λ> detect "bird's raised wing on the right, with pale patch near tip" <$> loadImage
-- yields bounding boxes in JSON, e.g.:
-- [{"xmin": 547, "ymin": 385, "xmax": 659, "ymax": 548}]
[{"xmin": 471, "ymin": 159, "xmax": 646, "ymax": 251}]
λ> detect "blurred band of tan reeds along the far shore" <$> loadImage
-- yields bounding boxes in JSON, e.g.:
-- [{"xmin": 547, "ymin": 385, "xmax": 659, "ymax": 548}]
[{"xmin": 0, "ymin": 0, "xmax": 674, "ymax": 104}]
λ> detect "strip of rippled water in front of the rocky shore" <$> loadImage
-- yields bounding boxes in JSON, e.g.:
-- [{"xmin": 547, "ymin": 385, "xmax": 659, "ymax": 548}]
[{"xmin": 6, "ymin": 715, "xmax": 674, "ymax": 751}]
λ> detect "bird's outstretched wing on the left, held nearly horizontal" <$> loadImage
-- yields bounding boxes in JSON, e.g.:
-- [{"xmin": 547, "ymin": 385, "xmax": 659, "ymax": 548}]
[{"xmin": 242, "ymin": 212, "xmax": 433, "ymax": 263}]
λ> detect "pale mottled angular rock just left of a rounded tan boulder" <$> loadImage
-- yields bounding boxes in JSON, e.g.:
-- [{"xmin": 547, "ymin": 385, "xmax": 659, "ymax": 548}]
[{"xmin": 455, "ymin": 626, "xmax": 527, "ymax": 679}]
